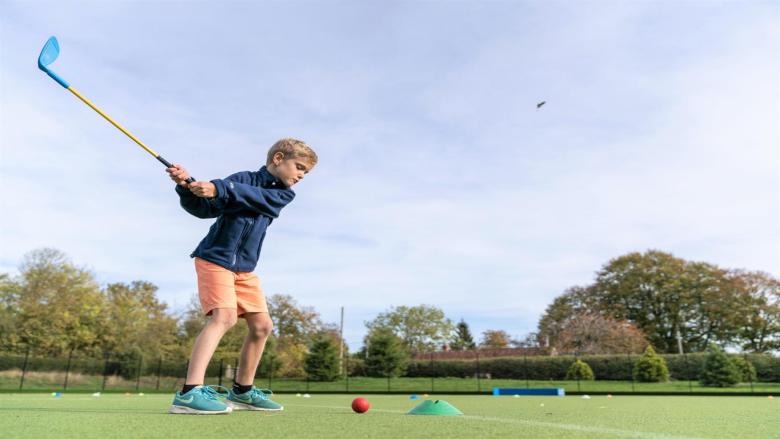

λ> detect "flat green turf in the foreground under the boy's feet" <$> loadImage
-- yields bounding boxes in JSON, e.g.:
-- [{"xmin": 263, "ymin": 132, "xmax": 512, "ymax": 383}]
[{"xmin": 0, "ymin": 393, "xmax": 780, "ymax": 439}]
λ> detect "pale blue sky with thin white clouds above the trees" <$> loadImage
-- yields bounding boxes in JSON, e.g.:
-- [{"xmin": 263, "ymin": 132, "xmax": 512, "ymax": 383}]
[{"xmin": 0, "ymin": 0, "xmax": 780, "ymax": 347}]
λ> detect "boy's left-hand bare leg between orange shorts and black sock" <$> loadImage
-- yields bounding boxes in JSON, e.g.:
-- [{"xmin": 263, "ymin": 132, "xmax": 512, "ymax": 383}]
[{"xmin": 185, "ymin": 308, "xmax": 237, "ymax": 384}]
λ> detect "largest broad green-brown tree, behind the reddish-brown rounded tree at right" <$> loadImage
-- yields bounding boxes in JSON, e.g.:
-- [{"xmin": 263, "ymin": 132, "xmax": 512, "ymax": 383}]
[{"xmin": 539, "ymin": 250, "xmax": 756, "ymax": 352}]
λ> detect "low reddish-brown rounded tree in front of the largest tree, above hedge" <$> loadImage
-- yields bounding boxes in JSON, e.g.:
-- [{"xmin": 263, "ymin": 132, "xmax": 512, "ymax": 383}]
[{"xmin": 551, "ymin": 313, "xmax": 647, "ymax": 355}]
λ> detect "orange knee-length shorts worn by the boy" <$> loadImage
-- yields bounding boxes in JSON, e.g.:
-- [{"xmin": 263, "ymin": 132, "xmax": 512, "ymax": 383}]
[{"xmin": 195, "ymin": 258, "xmax": 268, "ymax": 316}]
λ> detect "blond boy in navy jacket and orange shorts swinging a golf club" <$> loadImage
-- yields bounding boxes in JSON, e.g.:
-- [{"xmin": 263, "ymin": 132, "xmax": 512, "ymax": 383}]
[{"xmin": 166, "ymin": 139, "xmax": 317, "ymax": 414}]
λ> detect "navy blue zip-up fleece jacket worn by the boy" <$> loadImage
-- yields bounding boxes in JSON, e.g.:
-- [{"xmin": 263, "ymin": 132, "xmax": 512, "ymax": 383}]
[{"xmin": 176, "ymin": 166, "xmax": 295, "ymax": 272}]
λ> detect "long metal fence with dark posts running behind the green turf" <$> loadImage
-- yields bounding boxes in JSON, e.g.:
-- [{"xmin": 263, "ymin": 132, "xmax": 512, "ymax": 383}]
[{"xmin": 0, "ymin": 349, "xmax": 780, "ymax": 395}]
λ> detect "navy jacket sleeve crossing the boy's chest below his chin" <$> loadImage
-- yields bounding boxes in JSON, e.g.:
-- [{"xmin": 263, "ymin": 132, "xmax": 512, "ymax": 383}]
[{"xmin": 211, "ymin": 176, "xmax": 295, "ymax": 218}]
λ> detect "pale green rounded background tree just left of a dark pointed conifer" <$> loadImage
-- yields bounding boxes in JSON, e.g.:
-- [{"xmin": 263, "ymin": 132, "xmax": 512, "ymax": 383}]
[{"xmin": 366, "ymin": 305, "xmax": 454, "ymax": 352}]
